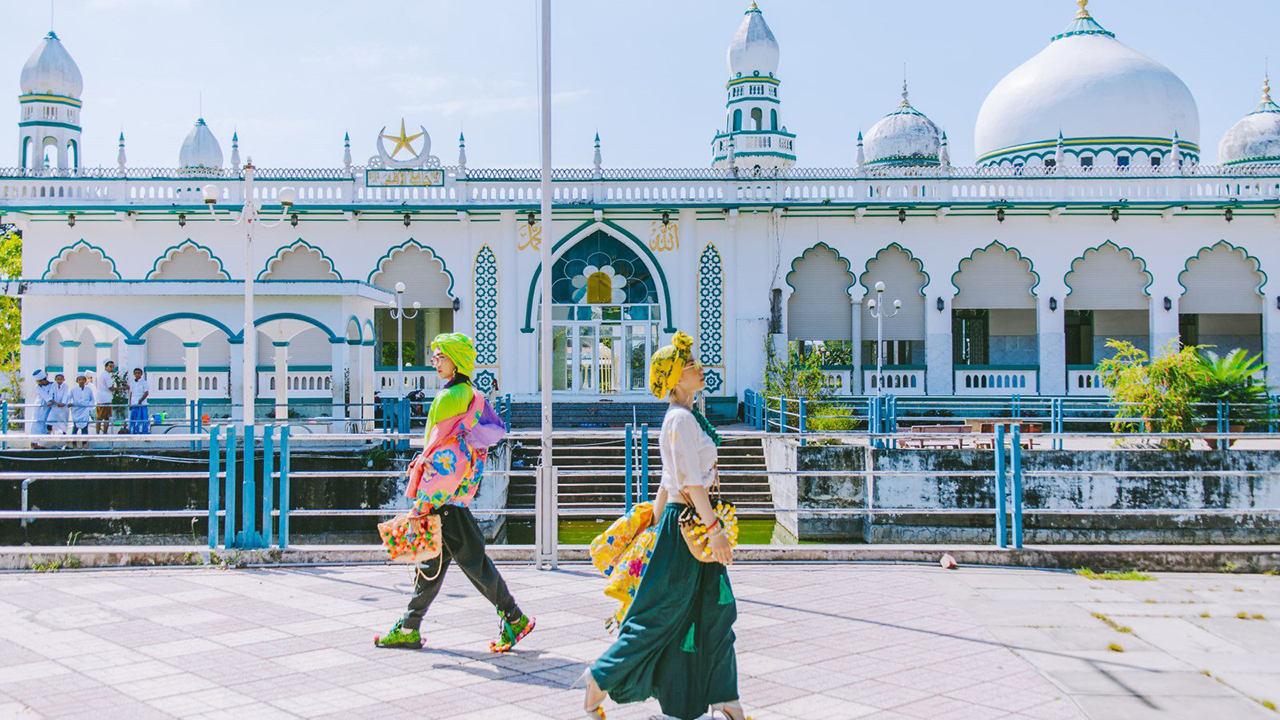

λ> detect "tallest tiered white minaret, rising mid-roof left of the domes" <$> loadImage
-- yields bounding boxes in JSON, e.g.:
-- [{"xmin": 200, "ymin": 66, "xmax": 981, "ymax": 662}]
[{"xmin": 712, "ymin": 3, "xmax": 796, "ymax": 170}]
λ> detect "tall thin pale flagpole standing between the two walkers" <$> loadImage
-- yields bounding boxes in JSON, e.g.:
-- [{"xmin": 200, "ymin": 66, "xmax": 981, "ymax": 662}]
[{"xmin": 530, "ymin": 0, "xmax": 557, "ymax": 568}]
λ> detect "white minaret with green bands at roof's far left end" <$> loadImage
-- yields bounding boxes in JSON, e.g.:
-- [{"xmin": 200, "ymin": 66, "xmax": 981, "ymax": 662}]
[{"xmin": 18, "ymin": 31, "xmax": 84, "ymax": 170}]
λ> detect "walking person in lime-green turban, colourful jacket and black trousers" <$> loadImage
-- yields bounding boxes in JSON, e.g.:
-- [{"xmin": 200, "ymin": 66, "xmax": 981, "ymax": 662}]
[{"xmin": 374, "ymin": 333, "xmax": 534, "ymax": 652}]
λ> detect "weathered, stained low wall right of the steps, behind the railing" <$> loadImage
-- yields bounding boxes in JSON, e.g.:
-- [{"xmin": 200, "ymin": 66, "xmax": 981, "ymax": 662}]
[{"xmin": 765, "ymin": 439, "xmax": 1280, "ymax": 544}]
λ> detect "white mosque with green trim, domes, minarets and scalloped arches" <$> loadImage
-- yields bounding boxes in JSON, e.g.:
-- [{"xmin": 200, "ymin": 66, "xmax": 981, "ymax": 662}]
[{"xmin": 0, "ymin": 0, "xmax": 1280, "ymax": 415}]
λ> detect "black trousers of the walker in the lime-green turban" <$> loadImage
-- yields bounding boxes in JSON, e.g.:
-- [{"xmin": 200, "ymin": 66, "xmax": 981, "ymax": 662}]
[{"xmin": 401, "ymin": 505, "xmax": 520, "ymax": 630}]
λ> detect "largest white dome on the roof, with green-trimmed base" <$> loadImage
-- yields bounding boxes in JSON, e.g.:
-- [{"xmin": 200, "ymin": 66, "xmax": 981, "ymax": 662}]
[{"xmin": 974, "ymin": 0, "xmax": 1199, "ymax": 165}]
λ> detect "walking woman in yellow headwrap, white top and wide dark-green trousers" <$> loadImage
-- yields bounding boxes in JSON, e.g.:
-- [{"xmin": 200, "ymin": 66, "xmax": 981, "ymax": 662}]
[{"xmin": 584, "ymin": 332, "xmax": 745, "ymax": 720}]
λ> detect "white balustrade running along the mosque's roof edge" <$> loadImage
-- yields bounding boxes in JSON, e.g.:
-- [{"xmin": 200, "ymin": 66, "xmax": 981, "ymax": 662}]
[{"xmin": 0, "ymin": 165, "xmax": 1280, "ymax": 207}]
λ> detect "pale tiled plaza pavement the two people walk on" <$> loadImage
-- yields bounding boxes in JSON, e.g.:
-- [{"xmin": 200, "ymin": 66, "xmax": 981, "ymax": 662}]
[{"xmin": 0, "ymin": 564, "xmax": 1280, "ymax": 720}]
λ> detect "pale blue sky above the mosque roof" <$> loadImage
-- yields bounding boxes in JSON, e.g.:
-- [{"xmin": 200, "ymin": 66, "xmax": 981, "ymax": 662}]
[{"xmin": 0, "ymin": 0, "xmax": 1280, "ymax": 168}]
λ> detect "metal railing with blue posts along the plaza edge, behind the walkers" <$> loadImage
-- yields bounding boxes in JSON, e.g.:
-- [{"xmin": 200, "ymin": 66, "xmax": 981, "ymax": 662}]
[{"xmin": 0, "ymin": 415, "xmax": 1280, "ymax": 558}]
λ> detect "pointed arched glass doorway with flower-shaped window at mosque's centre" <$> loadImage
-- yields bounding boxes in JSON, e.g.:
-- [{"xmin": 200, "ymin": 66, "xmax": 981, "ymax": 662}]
[{"xmin": 542, "ymin": 231, "xmax": 662, "ymax": 395}]
